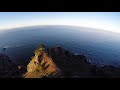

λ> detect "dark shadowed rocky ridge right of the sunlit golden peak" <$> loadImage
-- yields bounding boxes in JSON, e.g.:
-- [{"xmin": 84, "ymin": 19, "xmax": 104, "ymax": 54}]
[{"xmin": 47, "ymin": 47, "xmax": 120, "ymax": 78}]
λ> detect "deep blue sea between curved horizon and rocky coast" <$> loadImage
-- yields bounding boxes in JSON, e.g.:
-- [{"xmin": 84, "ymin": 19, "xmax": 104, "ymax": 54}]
[{"xmin": 0, "ymin": 26, "xmax": 120, "ymax": 66}]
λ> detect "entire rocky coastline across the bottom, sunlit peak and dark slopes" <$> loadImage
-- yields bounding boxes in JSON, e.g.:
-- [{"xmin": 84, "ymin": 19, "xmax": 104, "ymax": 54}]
[{"xmin": 0, "ymin": 45, "xmax": 120, "ymax": 78}]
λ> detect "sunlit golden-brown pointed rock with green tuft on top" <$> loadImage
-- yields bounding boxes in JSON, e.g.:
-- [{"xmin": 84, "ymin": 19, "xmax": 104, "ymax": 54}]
[{"xmin": 24, "ymin": 47, "xmax": 60, "ymax": 78}]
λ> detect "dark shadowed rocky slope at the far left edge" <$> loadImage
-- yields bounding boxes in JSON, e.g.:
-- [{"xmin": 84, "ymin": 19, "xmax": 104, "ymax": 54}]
[{"xmin": 0, "ymin": 54, "xmax": 19, "ymax": 78}]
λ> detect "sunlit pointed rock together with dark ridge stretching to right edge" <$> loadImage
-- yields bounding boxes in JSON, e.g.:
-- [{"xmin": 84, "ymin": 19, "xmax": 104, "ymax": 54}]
[{"xmin": 24, "ymin": 44, "xmax": 120, "ymax": 78}]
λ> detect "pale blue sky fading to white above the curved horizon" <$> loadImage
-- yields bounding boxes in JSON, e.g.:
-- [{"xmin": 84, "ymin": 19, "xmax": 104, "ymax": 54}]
[{"xmin": 0, "ymin": 12, "xmax": 120, "ymax": 32}]
